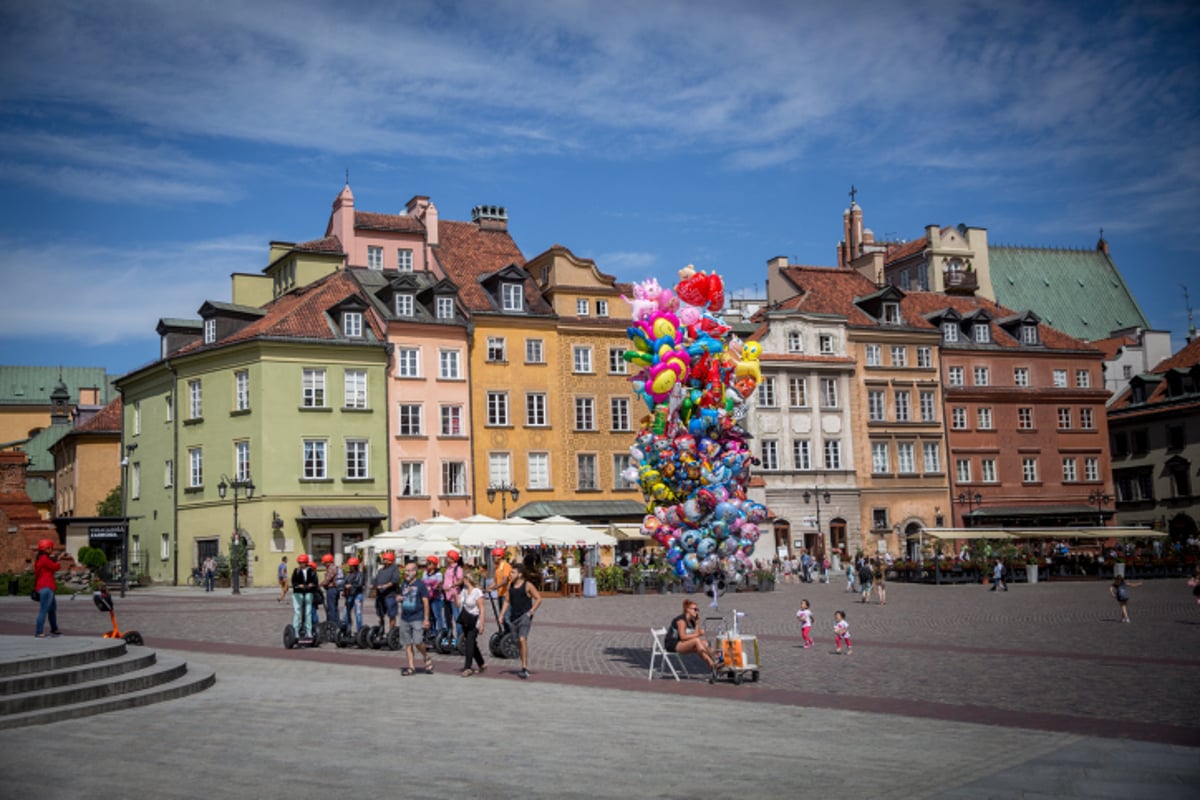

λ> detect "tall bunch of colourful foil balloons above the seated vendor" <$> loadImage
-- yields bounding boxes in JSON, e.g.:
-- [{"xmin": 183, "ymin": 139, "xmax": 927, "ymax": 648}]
[{"xmin": 624, "ymin": 265, "xmax": 768, "ymax": 578}]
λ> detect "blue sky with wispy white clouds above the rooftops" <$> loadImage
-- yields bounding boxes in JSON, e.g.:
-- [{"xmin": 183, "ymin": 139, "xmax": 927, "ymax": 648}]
[{"xmin": 0, "ymin": 0, "xmax": 1200, "ymax": 374}]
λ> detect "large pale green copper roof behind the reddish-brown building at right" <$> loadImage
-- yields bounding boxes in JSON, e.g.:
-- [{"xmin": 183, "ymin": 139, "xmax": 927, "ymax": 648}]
[{"xmin": 988, "ymin": 245, "xmax": 1150, "ymax": 341}]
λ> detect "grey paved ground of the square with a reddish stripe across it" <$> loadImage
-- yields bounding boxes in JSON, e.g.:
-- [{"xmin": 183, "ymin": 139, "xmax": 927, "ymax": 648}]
[{"xmin": 0, "ymin": 581, "xmax": 1200, "ymax": 799}]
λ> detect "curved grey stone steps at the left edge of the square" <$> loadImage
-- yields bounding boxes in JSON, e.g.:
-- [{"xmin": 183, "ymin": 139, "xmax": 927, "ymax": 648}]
[{"xmin": 0, "ymin": 637, "xmax": 216, "ymax": 729}]
